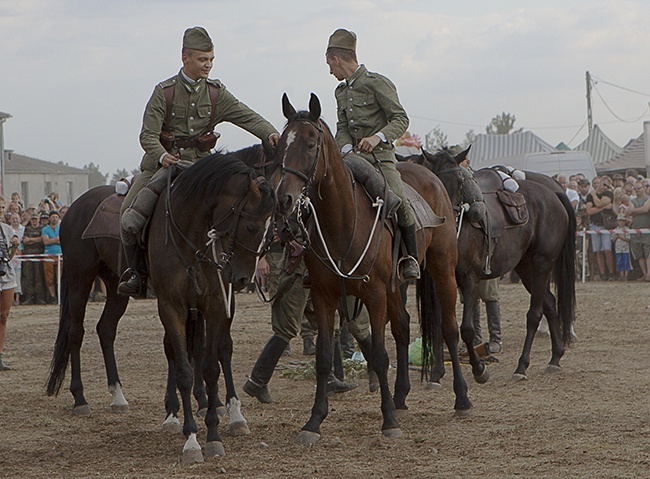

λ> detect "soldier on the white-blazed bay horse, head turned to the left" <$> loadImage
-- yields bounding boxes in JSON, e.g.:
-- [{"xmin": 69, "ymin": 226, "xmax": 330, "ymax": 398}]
[{"xmin": 325, "ymin": 28, "xmax": 420, "ymax": 280}]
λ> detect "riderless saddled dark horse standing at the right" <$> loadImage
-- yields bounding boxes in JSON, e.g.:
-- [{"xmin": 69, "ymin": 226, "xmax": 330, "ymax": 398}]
[{"xmin": 415, "ymin": 149, "xmax": 576, "ymax": 380}]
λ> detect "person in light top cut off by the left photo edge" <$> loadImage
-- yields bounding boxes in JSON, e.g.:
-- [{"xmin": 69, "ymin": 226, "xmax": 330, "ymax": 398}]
[{"xmin": 0, "ymin": 218, "xmax": 20, "ymax": 371}]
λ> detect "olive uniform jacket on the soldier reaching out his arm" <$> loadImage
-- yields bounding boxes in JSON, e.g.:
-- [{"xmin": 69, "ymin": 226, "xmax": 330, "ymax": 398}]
[{"xmin": 140, "ymin": 72, "xmax": 276, "ymax": 171}]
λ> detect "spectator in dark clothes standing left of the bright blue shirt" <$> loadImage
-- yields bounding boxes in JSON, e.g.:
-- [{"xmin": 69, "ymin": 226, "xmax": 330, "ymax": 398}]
[{"xmin": 21, "ymin": 212, "xmax": 45, "ymax": 305}]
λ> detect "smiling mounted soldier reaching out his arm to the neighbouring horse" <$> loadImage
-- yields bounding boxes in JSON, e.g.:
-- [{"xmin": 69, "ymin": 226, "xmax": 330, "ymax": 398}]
[{"xmin": 118, "ymin": 27, "xmax": 280, "ymax": 295}]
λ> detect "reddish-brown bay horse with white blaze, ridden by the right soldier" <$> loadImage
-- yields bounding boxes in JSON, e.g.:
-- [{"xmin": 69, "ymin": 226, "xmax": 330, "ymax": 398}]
[{"xmin": 271, "ymin": 93, "xmax": 472, "ymax": 445}]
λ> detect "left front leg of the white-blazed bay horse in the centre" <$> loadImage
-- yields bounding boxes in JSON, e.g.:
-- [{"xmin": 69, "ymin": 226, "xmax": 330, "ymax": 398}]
[{"xmin": 295, "ymin": 300, "xmax": 334, "ymax": 445}]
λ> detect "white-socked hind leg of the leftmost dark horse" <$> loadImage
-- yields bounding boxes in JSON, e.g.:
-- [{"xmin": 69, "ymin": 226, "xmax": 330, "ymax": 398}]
[{"xmin": 96, "ymin": 277, "xmax": 129, "ymax": 412}]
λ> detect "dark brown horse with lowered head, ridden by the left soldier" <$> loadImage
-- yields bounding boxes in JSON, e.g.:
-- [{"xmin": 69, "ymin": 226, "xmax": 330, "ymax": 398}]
[{"xmin": 47, "ymin": 145, "xmax": 275, "ymax": 460}]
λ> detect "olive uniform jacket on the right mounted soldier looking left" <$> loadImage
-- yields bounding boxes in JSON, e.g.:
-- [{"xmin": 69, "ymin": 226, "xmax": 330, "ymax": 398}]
[{"xmin": 334, "ymin": 65, "xmax": 409, "ymax": 161}]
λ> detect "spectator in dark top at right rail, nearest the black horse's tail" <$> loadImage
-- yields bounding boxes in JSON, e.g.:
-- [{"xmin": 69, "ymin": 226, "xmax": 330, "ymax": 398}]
[{"xmin": 587, "ymin": 176, "xmax": 615, "ymax": 280}]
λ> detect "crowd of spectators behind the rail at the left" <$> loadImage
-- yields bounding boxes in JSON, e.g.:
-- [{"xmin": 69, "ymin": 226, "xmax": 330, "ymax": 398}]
[{"xmin": 0, "ymin": 193, "xmax": 68, "ymax": 306}]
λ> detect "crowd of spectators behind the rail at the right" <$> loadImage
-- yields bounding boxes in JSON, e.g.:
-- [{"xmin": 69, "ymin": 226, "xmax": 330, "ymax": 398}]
[{"xmin": 556, "ymin": 170, "xmax": 650, "ymax": 281}]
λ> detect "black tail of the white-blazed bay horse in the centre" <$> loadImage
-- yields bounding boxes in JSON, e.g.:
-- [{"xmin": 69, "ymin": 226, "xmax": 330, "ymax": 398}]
[{"xmin": 416, "ymin": 268, "xmax": 442, "ymax": 379}]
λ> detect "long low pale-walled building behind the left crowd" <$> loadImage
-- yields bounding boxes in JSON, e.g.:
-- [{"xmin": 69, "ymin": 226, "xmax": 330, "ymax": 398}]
[{"xmin": 2, "ymin": 150, "xmax": 89, "ymax": 205}]
